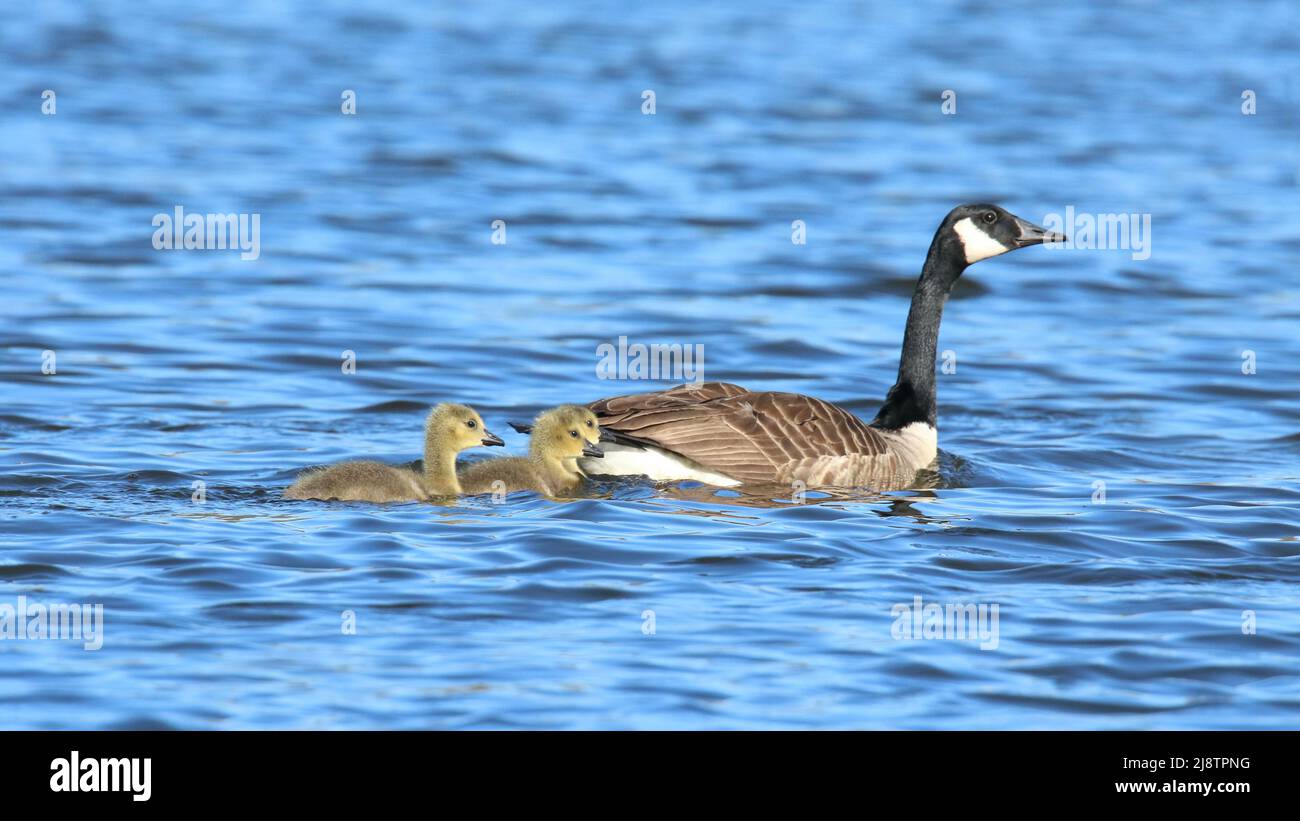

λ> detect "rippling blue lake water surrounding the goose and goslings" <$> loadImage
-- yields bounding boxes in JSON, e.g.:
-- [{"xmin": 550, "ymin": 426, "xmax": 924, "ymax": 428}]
[{"xmin": 0, "ymin": 1, "xmax": 1300, "ymax": 729}]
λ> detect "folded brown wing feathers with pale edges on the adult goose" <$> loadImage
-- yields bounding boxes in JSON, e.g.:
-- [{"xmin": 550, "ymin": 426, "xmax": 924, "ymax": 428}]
[{"xmin": 588, "ymin": 382, "xmax": 887, "ymax": 482}]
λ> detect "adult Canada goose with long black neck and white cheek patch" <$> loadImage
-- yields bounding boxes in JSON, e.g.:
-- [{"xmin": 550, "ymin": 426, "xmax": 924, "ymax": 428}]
[{"xmin": 581, "ymin": 204, "xmax": 1065, "ymax": 490}]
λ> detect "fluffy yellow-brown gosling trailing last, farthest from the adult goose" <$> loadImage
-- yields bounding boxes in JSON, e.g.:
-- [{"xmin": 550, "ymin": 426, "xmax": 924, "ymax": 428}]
[{"xmin": 285, "ymin": 403, "xmax": 506, "ymax": 501}]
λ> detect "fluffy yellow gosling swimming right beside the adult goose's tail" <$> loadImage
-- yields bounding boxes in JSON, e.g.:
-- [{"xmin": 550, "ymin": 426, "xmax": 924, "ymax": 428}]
[{"xmin": 460, "ymin": 405, "xmax": 603, "ymax": 496}]
